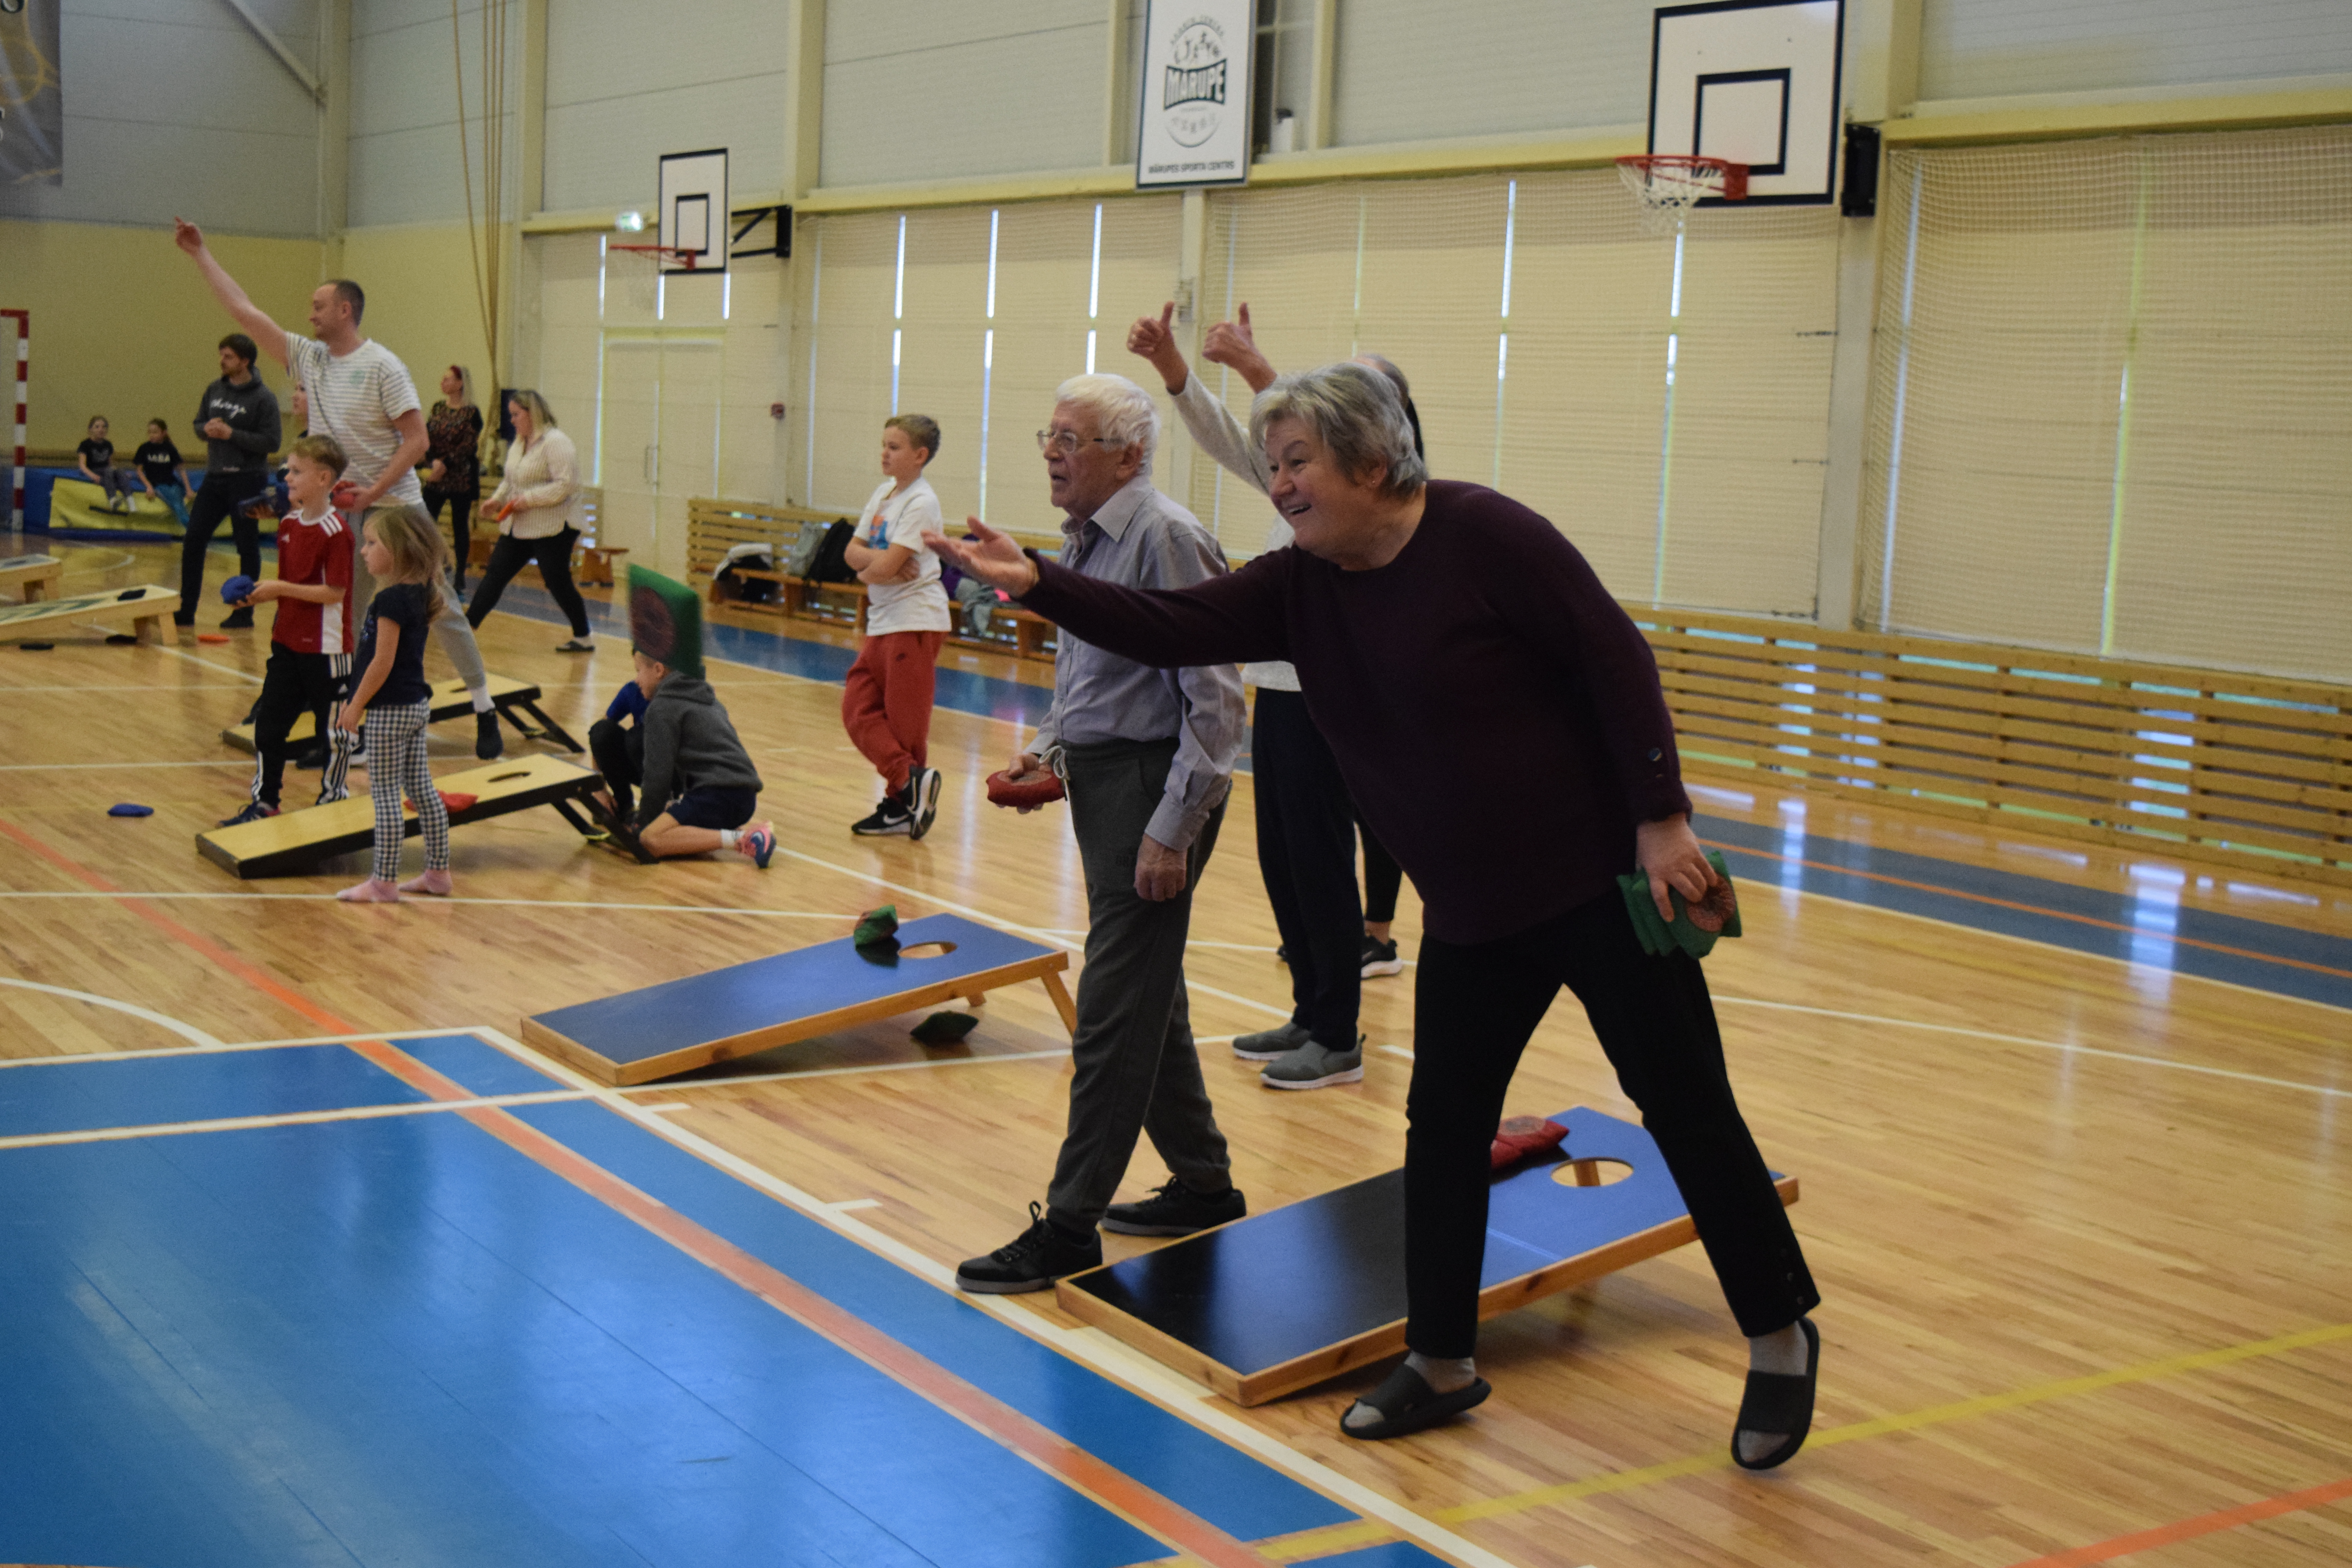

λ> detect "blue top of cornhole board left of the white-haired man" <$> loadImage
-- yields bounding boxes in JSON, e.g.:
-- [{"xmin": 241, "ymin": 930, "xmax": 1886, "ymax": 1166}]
[{"xmin": 532, "ymin": 915, "xmax": 1058, "ymax": 1065}]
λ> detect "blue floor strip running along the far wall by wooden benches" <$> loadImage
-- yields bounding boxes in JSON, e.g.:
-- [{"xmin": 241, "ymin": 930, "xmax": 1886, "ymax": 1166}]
[{"xmin": 499, "ymin": 588, "xmax": 2352, "ymax": 1006}]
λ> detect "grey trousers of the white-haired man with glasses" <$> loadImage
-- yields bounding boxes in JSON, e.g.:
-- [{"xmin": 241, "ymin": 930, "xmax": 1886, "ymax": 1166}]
[{"xmin": 1047, "ymin": 740, "xmax": 1232, "ymax": 1232}]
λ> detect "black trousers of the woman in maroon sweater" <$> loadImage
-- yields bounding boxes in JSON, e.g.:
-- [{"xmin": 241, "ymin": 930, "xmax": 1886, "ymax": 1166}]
[{"xmin": 1404, "ymin": 889, "xmax": 1820, "ymax": 1356}]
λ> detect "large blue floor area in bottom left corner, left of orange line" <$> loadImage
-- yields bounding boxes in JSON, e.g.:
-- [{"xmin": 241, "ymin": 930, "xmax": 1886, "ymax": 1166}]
[{"xmin": 0, "ymin": 1114, "xmax": 1167, "ymax": 1568}]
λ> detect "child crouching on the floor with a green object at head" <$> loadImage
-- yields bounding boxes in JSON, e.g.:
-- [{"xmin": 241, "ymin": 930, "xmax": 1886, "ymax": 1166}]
[{"xmin": 588, "ymin": 569, "xmax": 776, "ymax": 870}]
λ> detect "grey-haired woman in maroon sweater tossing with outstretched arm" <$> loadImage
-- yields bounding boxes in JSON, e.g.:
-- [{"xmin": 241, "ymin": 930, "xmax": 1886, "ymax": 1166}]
[{"xmin": 924, "ymin": 365, "xmax": 1820, "ymax": 1469}]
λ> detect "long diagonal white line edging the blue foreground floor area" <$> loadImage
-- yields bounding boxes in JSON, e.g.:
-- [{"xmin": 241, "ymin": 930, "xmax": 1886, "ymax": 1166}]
[{"xmin": 447, "ymin": 1027, "xmax": 1517, "ymax": 1568}]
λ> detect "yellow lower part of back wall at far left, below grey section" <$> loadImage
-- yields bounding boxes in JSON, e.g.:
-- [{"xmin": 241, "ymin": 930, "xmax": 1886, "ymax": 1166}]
[{"xmin": 0, "ymin": 219, "xmax": 320, "ymax": 458}]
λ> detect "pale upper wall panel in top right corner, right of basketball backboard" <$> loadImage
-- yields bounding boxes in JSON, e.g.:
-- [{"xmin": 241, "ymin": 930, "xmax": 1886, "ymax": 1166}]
[{"xmin": 1919, "ymin": 0, "xmax": 2352, "ymax": 99}]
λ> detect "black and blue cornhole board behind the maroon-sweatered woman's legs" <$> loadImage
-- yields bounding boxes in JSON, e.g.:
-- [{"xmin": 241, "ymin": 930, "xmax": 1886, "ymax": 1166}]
[{"xmin": 1056, "ymin": 1107, "xmax": 1797, "ymax": 1406}]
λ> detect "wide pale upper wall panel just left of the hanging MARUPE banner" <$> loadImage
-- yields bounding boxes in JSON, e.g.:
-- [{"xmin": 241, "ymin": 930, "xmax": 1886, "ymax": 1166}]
[{"xmin": 821, "ymin": 0, "xmax": 1110, "ymax": 186}]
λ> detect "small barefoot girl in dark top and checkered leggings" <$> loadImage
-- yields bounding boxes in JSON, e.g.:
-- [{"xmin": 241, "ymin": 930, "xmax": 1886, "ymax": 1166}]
[{"xmin": 336, "ymin": 512, "xmax": 452, "ymax": 903}]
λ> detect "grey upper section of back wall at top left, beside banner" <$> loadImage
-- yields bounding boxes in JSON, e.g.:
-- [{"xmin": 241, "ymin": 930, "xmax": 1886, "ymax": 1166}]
[{"xmin": 0, "ymin": 0, "xmax": 320, "ymax": 235}]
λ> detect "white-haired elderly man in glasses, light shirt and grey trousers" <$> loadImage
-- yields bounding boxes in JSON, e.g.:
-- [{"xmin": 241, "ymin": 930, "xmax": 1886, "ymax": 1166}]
[{"xmin": 955, "ymin": 376, "xmax": 1249, "ymax": 1293}]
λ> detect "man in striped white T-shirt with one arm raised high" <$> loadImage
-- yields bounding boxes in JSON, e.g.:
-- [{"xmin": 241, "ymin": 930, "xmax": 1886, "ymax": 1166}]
[{"xmin": 172, "ymin": 219, "xmax": 503, "ymax": 762}]
